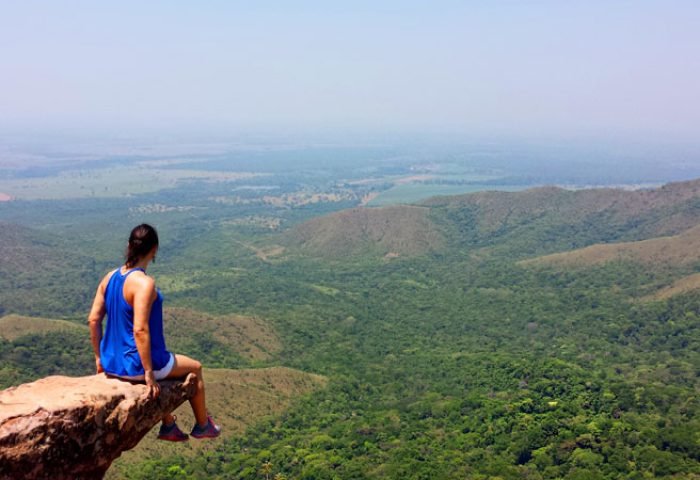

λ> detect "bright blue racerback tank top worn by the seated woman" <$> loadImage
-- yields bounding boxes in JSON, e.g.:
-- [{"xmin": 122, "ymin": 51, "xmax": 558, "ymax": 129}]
[{"xmin": 100, "ymin": 268, "xmax": 170, "ymax": 377}]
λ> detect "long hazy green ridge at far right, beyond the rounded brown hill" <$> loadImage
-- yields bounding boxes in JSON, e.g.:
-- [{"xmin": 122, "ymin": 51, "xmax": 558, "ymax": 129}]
[{"xmin": 423, "ymin": 180, "xmax": 700, "ymax": 258}]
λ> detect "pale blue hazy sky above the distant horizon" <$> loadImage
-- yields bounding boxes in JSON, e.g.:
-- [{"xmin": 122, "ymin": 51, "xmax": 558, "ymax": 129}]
[{"xmin": 0, "ymin": 0, "xmax": 700, "ymax": 139}]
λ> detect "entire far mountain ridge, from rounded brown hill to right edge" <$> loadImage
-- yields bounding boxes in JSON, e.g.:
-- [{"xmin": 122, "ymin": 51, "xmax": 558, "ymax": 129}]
[{"xmin": 286, "ymin": 179, "xmax": 700, "ymax": 258}]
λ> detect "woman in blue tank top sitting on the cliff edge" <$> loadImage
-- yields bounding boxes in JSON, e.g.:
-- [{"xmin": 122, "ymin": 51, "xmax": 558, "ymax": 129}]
[{"xmin": 88, "ymin": 224, "xmax": 221, "ymax": 442}]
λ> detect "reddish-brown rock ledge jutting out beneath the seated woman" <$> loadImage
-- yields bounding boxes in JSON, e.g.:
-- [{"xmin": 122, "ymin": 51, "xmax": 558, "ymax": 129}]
[{"xmin": 0, "ymin": 374, "xmax": 197, "ymax": 480}]
